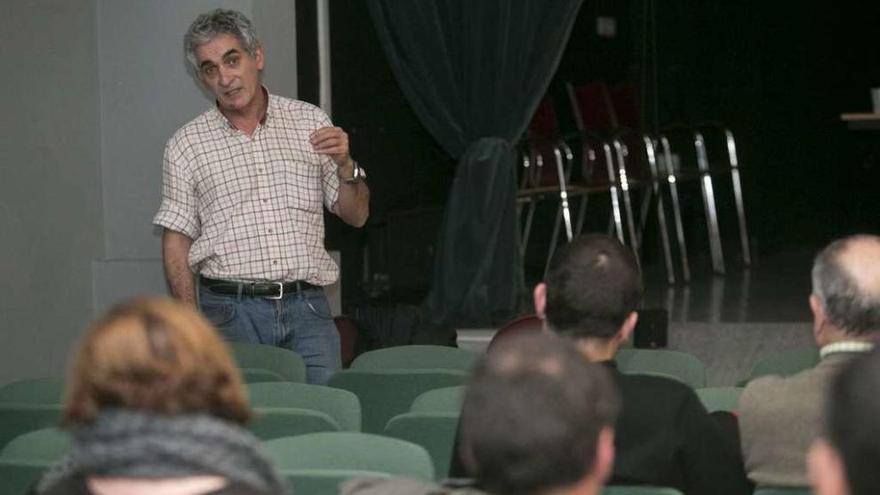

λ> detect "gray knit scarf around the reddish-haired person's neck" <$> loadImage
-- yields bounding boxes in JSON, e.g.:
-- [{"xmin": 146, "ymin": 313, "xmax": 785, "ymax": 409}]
[{"xmin": 37, "ymin": 409, "xmax": 285, "ymax": 493}]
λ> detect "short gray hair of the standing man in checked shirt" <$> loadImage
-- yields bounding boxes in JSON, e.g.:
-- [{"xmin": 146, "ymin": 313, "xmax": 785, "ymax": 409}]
[{"xmin": 183, "ymin": 9, "xmax": 260, "ymax": 72}]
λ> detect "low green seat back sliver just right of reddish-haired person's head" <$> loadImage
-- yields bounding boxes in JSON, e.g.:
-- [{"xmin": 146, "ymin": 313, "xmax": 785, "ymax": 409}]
[{"xmin": 248, "ymin": 407, "xmax": 342, "ymax": 440}]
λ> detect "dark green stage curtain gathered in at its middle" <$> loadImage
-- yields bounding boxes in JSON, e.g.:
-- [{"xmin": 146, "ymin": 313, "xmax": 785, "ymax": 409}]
[{"xmin": 369, "ymin": 0, "xmax": 581, "ymax": 326}]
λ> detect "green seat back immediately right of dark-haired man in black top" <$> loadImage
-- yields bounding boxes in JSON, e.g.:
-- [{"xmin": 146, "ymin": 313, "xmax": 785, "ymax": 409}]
[{"xmin": 614, "ymin": 349, "xmax": 706, "ymax": 389}]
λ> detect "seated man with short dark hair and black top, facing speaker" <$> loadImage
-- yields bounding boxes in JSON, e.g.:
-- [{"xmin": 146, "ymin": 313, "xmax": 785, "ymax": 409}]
[{"xmin": 534, "ymin": 234, "xmax": 751, "ymax": 495}]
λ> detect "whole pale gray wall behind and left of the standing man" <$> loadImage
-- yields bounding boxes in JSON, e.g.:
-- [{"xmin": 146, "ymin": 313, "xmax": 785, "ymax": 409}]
[{"xmin": 0, "ymin": 0, "xmax": 296, "ymax": 383}]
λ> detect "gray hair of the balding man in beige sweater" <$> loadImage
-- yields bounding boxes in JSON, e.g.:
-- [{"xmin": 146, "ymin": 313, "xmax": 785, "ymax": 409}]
[{"xmin": 813, "ymin": 235, "xmax": 880, "ymax": 335}]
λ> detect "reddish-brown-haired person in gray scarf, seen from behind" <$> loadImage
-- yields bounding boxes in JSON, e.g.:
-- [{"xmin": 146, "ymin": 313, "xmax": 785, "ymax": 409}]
[{"xmin": 38, "ymin": 299, "xmax": 283, "ymax": 495}]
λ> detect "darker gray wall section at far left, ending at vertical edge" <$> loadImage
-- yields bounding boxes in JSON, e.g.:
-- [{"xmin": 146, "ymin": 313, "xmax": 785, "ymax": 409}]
[{"xmin": 0, "ymin": 0, "xmax": 103, "ymax": 383}]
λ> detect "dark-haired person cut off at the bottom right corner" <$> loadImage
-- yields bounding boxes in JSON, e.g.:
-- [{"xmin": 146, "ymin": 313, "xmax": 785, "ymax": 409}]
[{"xmin": 808, "ymin": 350, "xmax": 880, "ymax": 495}]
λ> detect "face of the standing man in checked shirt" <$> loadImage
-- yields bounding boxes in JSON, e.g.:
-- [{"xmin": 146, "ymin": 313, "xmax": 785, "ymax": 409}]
[{"xmin": 196, "ymin": 34, "xmax": 265, "ymax": 113}]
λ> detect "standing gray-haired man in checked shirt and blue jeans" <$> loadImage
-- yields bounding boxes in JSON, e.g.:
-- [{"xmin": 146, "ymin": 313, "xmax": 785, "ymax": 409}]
[{"xmin": 153, "ymin": 9, "xmax": 369, "ymax": 384}]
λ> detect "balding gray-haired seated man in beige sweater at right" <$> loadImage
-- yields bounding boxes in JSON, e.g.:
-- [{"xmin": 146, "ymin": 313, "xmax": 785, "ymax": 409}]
[{"xmin": 739, "ymin": 235, "xmax": 880, "ymax": 486}]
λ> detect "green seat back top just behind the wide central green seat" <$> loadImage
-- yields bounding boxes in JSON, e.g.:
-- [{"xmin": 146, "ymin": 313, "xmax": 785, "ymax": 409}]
[{"xmin": 351, "ymin": 345, "xmax": 479, "ymax": 371}]
